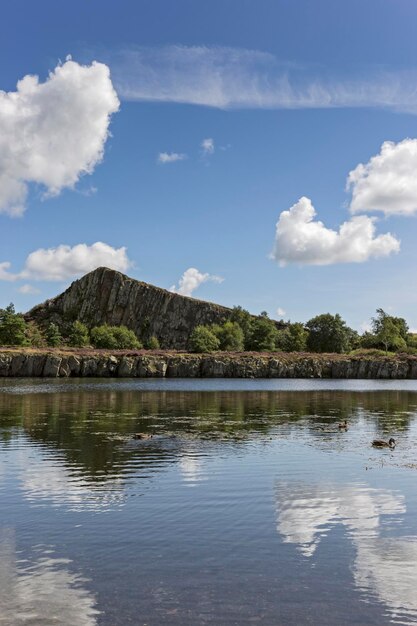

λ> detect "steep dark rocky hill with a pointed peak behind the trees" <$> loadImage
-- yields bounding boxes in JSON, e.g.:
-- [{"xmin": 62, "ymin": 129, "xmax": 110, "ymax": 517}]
[{"xmin": 25, "ymin": 267, "xmax": 282, "ymax": 350}]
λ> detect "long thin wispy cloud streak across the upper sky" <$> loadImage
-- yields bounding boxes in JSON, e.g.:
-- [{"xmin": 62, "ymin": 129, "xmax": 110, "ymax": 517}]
[{"xmin": 110, "ymin": 46, "xmax": 417, "ymax": 113}]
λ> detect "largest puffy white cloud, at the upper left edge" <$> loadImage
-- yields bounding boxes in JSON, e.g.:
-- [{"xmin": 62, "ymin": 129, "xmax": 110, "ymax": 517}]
[{"xmin": 0, "ymin": 59, "xmax": 119, "ymax": 216}]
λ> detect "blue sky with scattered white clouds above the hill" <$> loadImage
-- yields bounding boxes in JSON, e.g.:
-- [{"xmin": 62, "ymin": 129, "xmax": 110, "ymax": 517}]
[{"xmin": 0, "ymin": 0, "xmax": 417, "ymax": 330}]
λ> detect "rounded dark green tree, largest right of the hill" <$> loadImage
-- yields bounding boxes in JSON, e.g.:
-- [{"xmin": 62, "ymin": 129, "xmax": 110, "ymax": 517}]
[{"xmin": 306, "ymin": 313, "xmax": 356, "ymax": 353}]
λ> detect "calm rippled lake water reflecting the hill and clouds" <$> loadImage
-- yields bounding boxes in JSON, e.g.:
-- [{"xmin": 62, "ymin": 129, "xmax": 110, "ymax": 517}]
[{"xmin": 0, "ymin": 379, "xmax": 417, "ymax": 626}]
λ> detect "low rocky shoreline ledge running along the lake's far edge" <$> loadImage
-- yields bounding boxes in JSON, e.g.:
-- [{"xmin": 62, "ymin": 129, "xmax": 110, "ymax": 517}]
[{"xmin": 0, "ymin": 349, "xmax": 417, "ymax": 379}]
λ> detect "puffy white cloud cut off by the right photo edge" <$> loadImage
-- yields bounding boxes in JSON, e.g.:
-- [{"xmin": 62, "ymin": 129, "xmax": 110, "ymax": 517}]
[{"xmin": 347, "ymin": 139, "xmax": 417, "ymax": 215}]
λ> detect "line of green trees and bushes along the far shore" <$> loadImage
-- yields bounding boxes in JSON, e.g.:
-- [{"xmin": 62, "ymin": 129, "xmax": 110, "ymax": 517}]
[{"xmin": 0, "ymin": 304, "xmax": 417, "ymax": 354}]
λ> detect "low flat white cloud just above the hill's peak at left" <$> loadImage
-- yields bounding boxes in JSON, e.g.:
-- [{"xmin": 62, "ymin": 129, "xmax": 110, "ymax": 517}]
[{"xmin": 0, "ymin": 241, "xmax": 132, "ymax": 281}]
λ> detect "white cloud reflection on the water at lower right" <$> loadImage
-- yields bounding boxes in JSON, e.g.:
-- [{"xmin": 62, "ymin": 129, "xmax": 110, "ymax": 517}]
[{"xmin": 276, "ymin": 482, "xmax": 417, "ymax": 624}]
